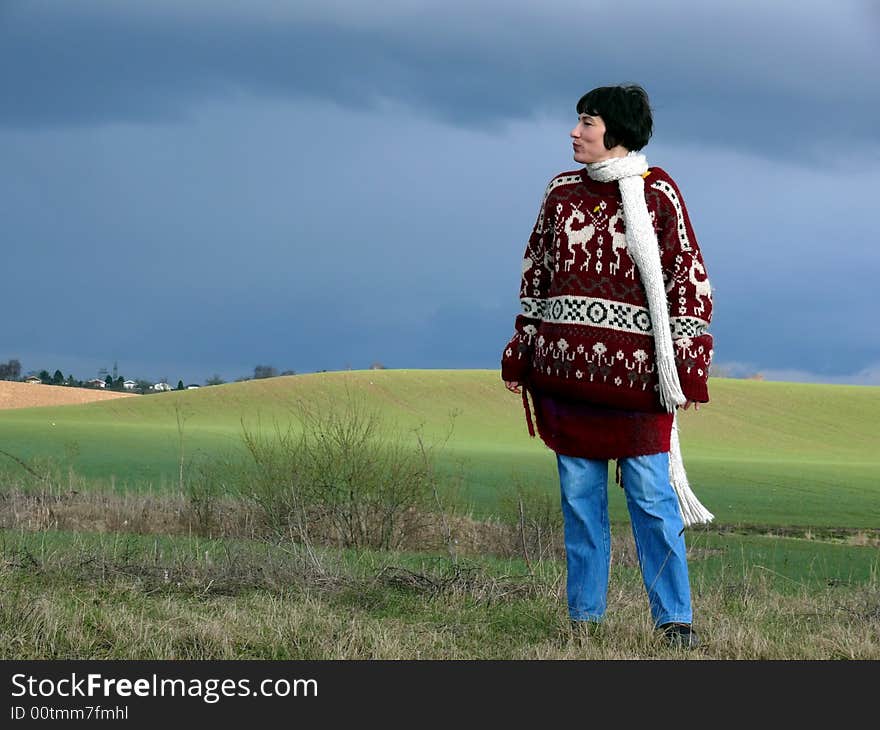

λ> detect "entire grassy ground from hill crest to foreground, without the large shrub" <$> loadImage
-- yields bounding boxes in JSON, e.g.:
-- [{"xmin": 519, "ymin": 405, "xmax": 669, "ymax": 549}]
[{"xmin": 0, "ymin": 370, "xmax": 880, "ymax": 659}]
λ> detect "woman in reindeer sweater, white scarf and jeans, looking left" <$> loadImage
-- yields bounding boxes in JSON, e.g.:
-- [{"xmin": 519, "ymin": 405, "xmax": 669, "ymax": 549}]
[{"xmin": 501, "ymin": 85, "xmax": 713, "ymax": 648}]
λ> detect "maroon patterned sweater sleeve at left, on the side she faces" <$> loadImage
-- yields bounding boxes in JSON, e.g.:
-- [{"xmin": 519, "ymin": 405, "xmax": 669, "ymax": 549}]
[{"xmin": 501, "ymin": 181, "xmax": 556, "ymax": 382}]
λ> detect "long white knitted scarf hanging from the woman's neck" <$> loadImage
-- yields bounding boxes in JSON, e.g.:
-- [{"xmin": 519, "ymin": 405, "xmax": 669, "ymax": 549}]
[{"xmin": 586, "ymin": 152, "xmax": 715, "ymax": 527}]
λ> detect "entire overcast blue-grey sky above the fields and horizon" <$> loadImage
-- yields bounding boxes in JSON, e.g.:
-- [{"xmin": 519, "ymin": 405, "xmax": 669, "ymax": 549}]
[{"xmin": 0, "ymin": 0, "xmax": 880, "ymax": 385}]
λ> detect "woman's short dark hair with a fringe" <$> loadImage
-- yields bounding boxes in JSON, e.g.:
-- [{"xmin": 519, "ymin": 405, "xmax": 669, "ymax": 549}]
[{"xmin": 577, "ymin": 84, "xmax": 654, "ymax": 152}]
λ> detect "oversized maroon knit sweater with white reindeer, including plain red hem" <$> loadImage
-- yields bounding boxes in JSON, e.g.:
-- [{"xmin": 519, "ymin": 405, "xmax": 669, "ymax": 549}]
[{"xmin": 501, "ymin": 167, "xmax": 713, "ymax": 458}]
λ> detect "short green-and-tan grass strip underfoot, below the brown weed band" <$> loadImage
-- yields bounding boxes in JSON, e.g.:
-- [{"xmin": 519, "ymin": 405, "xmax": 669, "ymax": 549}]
[{"xmin": 0, "ymin": 530, "xmax": 880, "ymax": 659}]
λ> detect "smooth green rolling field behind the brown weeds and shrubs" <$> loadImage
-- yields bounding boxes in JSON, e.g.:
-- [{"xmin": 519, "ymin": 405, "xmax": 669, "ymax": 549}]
[{"xmin": 0, "ymin": 370, "xmax": 880, "ymax": 529}]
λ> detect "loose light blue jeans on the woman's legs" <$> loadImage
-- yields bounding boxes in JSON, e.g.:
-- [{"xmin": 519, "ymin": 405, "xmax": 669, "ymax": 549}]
[{"xmin": 556, "ymin": 453, "xmax": 693, "ymax": 626}]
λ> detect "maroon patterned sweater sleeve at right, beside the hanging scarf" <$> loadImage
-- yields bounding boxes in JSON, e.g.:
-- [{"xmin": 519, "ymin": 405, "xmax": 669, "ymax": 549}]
[{"xmin": 647, "ymin": 171, "xmax": 714, "ymax": 403}]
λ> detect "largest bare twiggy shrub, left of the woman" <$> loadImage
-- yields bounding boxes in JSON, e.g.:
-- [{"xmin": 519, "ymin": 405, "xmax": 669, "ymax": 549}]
[{"xmin": 235, "ymin": 393, "xmax": 435, "ymax": 549}]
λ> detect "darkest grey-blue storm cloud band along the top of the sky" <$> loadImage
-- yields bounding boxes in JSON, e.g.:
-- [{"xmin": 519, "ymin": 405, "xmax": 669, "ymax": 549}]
[{"xmin": 0, "ymin": 0, "xmax": 880, "ymax": 158}]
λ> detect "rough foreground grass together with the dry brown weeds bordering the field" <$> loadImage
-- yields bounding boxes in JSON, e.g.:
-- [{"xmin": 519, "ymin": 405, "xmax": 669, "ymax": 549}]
[{"xmin": 0, "ymin": 481, "xmax": 880, "ymax": 659}]
